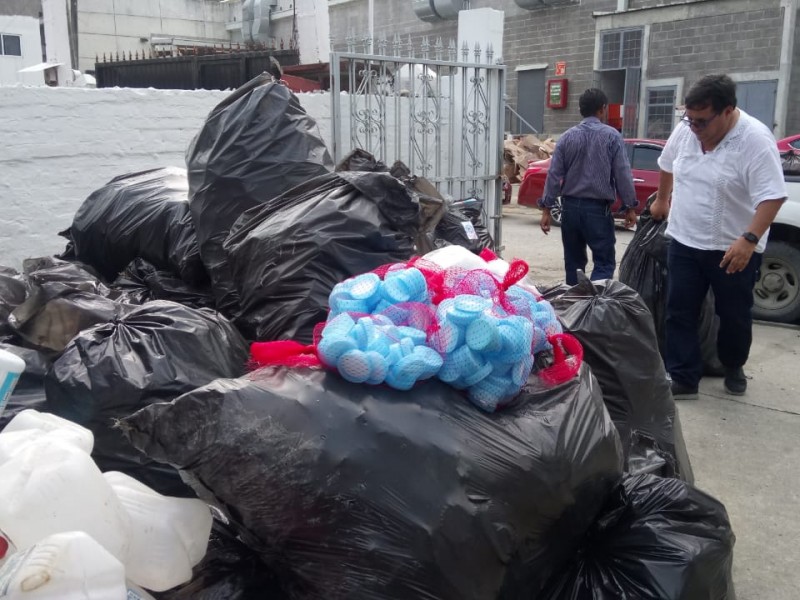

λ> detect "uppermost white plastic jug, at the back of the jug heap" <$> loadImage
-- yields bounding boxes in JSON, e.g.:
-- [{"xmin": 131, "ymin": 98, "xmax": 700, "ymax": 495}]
[{"xmin": 0, "ymin": 409, "xmax": 94, "ymax": 464}]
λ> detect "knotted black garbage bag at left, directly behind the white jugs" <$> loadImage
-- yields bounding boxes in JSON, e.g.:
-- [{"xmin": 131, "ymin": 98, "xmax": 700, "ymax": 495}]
[{"xmin": 45, "ymin": 300, "xmax": 249, "ymax": 496}]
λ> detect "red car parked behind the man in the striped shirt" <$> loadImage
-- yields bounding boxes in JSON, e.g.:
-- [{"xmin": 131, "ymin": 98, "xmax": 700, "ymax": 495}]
[{"xmin": 517, "ymin": 139, "xmax": 666, "ymax": 225}]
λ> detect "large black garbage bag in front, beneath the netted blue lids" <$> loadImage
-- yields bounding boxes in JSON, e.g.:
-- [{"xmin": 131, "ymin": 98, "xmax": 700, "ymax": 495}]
[{"xmin": 121, "ymin": 368, "xmax": 622, "ymax": 600}]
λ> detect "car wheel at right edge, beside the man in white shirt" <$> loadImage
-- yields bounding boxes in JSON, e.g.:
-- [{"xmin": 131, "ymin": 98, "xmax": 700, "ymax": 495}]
[{"xmin": 753, "ymin": 241, "xmax": 800, "ymax": 323}]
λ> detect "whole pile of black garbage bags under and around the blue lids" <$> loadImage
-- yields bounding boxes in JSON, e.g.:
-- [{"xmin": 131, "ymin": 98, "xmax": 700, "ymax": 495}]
[{"xmin": 0, "ymin": 77, "xmax": 734, "ymax": 600}]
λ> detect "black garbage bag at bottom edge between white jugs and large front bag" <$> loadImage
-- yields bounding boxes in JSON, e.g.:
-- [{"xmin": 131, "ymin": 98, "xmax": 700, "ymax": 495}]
[{"xmin": 157, "ymin": 519, "xmax": 285, "ymax": 600}]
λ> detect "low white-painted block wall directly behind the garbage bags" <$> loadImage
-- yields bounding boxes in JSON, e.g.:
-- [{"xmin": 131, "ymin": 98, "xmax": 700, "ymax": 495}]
[{"xmin": 0, "ymin": 87, "xmax": 331, "ymax": 268}]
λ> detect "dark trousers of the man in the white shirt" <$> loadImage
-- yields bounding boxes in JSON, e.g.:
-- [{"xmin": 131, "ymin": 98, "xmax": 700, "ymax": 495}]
[{"xmin": 665, "ymin": 240, "xmax": 761, "ymax": 387}]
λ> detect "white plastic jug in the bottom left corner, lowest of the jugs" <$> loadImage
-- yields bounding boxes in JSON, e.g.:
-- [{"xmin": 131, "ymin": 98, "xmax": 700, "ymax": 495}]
[{"xmin": 0, "ymin": 531, "xmax": 128, "ymax": 600}]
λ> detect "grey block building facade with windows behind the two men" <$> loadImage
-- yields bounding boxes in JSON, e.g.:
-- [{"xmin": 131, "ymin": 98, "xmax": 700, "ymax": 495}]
[{"xmin": 328, "ymin": 0, "xmax": 800, "ymax": 138}]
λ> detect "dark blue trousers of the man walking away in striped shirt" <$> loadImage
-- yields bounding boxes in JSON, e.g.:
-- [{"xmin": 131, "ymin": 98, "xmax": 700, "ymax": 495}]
[{"xmin": 561, "ymin": 197, "xmax": 617, "ymax": 285}]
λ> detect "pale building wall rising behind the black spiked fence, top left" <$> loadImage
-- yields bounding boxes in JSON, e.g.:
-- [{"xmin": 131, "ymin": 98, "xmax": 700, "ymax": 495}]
[{"xmin": 78, "ymin": 0, "xmax": 234, "ymax": 71}]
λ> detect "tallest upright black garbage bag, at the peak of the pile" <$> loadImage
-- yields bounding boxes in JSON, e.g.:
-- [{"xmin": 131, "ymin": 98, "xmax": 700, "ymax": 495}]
[{"xmin": 186, "ymin": 75, "xmax": 334, "ymax": 314}]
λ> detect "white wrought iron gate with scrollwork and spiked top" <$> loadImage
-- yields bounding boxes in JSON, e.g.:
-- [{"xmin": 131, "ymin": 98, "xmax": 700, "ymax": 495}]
[{"xmin": 331, "ymin": 36, "xmax": 505, "ymax": 247}]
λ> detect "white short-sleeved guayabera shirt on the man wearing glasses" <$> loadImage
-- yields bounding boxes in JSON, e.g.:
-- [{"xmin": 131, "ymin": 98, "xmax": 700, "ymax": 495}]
[{"xmin": 658, "ymin": 109, "xmax": 787, "ymax": 252}]
